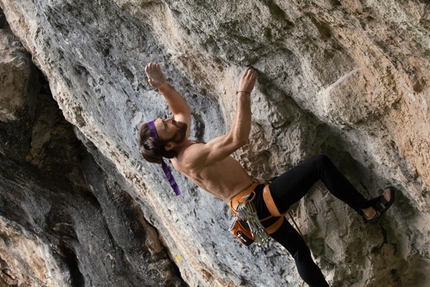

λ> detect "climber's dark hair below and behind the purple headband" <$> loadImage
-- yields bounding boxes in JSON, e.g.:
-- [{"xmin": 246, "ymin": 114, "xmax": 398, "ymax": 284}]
[{"xmin": 138, "ymin": 123, "xmax": 177, "ymax": 163}]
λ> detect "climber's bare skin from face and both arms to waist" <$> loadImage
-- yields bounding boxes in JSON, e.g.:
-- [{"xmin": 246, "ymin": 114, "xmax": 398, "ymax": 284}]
[{"xmin": 145, "ymin": 62, "xmax": 258, "ymax": 201}]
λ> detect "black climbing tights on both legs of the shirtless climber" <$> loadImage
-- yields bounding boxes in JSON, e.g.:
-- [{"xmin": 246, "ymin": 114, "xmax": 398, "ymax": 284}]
[{"xmin": 254, "ymin": 155, "xmax": 368, "ymax": 287}]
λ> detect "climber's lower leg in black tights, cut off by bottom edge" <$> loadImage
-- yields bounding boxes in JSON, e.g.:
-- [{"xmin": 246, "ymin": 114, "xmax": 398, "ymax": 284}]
[{"xmin": 270, "ymin": 220, "xmax": 329, "ymax": 287}]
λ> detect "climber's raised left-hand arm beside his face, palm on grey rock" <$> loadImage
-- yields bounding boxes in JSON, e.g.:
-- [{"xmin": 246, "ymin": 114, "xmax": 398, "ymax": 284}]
[{"xmin": 145, "ymin": 62, "xmax": 191, "ymax": 137}]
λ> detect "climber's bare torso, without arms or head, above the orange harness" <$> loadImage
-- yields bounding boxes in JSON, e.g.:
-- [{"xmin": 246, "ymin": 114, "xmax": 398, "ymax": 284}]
[{"xmin": 172, "ymin": 143, "xmax": 252, "ymax": 202}]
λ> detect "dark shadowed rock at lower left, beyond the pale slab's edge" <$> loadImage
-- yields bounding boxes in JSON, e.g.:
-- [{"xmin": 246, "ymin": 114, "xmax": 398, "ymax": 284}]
[{"xmin": 0, "ymin": 11, "xmax": 185, "ymax": 286}]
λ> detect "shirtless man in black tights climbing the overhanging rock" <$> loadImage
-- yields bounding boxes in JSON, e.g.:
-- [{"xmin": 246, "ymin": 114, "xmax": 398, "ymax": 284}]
[{"xmin": 138, "ymin": 63, "xmax": 394, "ymax": 287}]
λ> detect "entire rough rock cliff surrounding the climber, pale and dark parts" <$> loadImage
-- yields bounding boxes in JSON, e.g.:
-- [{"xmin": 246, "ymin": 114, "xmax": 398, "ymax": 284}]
[{"xmin": 0, "ymin": 0, "xmax": 430, "ymax": 287}]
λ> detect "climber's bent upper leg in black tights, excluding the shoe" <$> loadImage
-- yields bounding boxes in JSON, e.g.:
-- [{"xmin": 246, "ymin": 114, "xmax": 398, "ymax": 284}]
[{"xmin": 270, "ymin": 155, "xmax": 369, "ymax": 215}]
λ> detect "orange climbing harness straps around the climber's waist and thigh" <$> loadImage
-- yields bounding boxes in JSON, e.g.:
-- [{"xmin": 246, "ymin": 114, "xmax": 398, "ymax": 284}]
[{"xmin": 230, "ymin": 180, "xmax": 286, "ymax": 234}]
